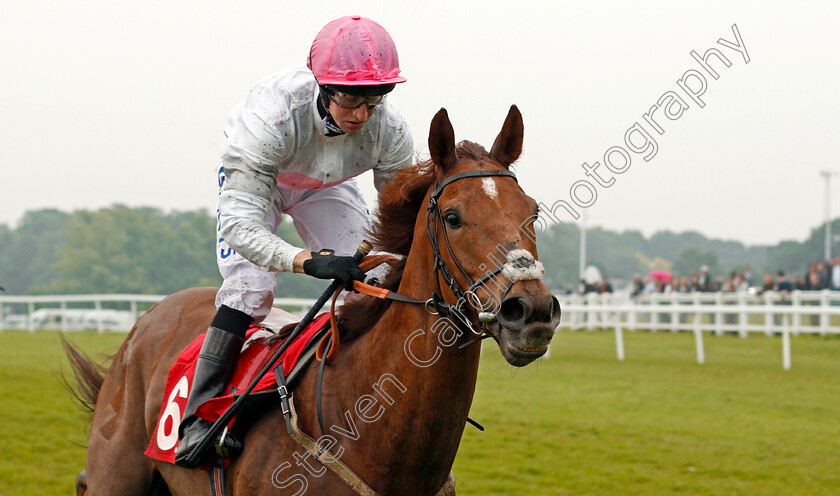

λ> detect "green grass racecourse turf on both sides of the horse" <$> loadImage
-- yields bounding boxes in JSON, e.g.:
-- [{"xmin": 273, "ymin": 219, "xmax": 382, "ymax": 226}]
[{"xmin": 0, "ymin": 331, "xmax": 840, "ymax": 496}]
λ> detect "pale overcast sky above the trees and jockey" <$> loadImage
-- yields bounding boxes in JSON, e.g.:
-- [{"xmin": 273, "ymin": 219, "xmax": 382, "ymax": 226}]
[{"xmin": 0, "ymin": 0, "xmax": 840, "ymax": 244}]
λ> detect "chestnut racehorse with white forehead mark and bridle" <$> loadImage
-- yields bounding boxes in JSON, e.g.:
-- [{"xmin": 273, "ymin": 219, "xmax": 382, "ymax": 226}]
[{"xmin": 68, "ymin": 106, "xmax": 560, "ymax": 496}]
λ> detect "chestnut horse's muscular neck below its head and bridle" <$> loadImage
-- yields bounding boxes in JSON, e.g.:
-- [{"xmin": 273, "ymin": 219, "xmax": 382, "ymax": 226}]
[{"xmin": 338, "ymin": 260, "xmax": 480, "ymax": 487}]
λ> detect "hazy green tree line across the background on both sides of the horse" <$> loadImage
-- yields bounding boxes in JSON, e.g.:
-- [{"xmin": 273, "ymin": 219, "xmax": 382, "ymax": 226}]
[{"xmin": 0, "ymin": 205, "xmax": 840, "ymax": 298}]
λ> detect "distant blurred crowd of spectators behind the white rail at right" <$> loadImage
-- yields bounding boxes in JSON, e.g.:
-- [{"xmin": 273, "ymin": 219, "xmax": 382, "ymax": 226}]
[{"xmin": 566, "ymin": 256, "xmax": 840, "ymax": 296}]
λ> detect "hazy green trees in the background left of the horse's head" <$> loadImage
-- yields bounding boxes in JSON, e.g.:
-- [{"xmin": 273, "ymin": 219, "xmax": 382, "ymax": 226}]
[{"xmin": 0, "ymin": 205, "xmax": 325, "ymax": 298}]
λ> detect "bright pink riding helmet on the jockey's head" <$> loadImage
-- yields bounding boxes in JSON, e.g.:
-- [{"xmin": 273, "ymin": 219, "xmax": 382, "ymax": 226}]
[{"xmin": 306, "ymin": 15, "xmax": 405, "ymax": 86}]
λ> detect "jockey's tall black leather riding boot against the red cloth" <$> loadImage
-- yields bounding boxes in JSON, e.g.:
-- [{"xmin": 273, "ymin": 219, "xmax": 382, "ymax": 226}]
[{"xmin": 175, "ymin": 321, "xmax": 244, "ymax": 468}]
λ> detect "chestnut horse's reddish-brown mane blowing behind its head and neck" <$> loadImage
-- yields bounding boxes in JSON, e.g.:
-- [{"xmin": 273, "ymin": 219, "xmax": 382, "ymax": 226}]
[{"xmin": 338, "ymin": 141, "xmax": 492, "ymax": 341}]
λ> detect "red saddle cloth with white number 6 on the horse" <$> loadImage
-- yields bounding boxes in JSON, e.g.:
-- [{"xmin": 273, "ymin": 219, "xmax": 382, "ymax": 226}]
[{"xmin": 144, "ymin": 313, "xmax": 330, "ymax": 463}]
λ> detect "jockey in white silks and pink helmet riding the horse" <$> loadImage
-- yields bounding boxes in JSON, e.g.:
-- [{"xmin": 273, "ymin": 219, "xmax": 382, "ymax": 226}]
[{"xmin": 175, "ymin": 16, "xmax": 414, "ymax": 466}]
